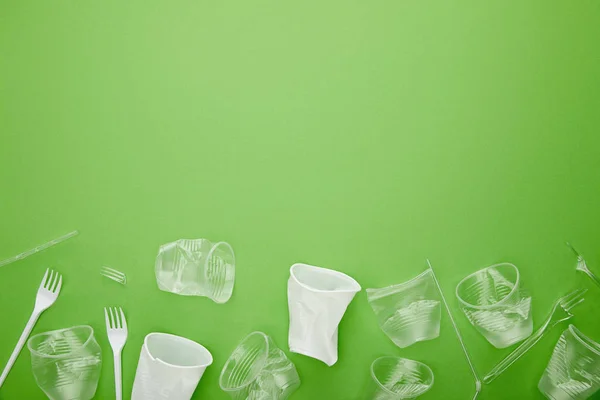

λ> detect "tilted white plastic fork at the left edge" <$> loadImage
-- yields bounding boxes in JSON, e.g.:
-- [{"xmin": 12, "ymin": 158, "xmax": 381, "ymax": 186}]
[{"xmin": 0, "ymin": 268, "xmax": 62, "ymax": 387}]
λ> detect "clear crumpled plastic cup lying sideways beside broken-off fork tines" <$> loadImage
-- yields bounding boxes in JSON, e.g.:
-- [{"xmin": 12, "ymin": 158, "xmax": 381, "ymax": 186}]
[{"xmin": 155, "ymin": 239, "xmax": 235, "ymax": 303}]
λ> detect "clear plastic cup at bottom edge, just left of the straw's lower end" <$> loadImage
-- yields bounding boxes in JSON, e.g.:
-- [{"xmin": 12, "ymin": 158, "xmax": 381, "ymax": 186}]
[{"xmin": 362, "ymin": 356, "xmax": 433, "ymax": 400}]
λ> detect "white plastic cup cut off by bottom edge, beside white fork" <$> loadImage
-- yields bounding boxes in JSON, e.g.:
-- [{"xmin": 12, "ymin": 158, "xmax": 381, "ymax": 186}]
[{"xmin": 131, "ymin": 333, "xmax": 213, "ymax": 400}]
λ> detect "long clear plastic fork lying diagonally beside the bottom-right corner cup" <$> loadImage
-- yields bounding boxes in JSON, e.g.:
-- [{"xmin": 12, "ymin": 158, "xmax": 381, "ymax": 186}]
[{"xmin": 483, "ymin": 289, "xmax": 587, "ymax": 383}]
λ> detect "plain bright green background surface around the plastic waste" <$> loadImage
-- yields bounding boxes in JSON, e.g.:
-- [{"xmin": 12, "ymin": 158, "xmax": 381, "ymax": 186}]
[{"xmin": 0, "ymin": 0, "xmax": 600, "ymax": 400}]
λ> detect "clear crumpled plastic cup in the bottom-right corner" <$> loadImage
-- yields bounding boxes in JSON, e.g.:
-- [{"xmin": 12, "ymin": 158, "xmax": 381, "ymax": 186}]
[{"xmin": 538, "ymin": 325, "xmax": 600, "ymax": 400}]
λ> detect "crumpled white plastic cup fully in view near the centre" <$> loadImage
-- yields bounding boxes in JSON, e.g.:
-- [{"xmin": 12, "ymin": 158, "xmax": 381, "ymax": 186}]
[{"xmin": 288, "ymin": 264, "xmax": 361, "ymax": 366}]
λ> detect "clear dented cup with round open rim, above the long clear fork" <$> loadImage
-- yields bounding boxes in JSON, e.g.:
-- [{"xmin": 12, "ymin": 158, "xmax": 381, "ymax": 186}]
[{"xmin": 456, "ymin": 263, "xmax": 533, "ymax": 349}]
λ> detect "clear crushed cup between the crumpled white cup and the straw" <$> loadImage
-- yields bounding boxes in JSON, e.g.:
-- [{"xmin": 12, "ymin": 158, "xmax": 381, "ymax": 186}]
[{"xmin": 367, "ymin": 269, "xmax": 442, "ymax": 348}]
